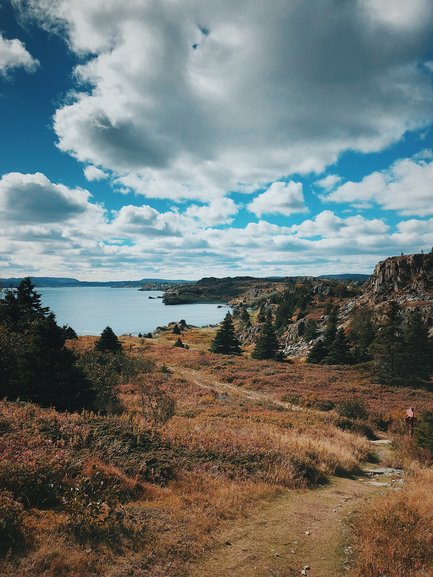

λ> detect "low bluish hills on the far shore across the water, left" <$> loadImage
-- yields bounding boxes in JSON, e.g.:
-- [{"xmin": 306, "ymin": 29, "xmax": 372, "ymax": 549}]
[{"xmin": 0, "ymin": 276, "xmax": 189, "ymax": 288}]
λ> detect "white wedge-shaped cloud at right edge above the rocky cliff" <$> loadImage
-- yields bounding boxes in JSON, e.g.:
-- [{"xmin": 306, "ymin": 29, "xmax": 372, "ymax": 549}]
[{"xmin": 322, "ymin": 153, "xmax": 433, "ymax": 216}]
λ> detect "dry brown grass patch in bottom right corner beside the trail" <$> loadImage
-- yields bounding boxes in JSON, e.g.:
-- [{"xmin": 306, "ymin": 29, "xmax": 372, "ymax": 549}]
[{"xmin": 353, "ymin": 469, "xmax": 433, "ymax": 577}]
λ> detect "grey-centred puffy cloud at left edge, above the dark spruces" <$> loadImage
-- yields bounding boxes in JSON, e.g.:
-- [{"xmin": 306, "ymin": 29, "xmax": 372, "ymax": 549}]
[{"xmin": 0, "ymin": 172, "xmax": 100, "ymax": 225}]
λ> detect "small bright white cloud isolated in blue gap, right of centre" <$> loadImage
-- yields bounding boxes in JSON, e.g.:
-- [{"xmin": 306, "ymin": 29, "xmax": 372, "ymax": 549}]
[{"xmin": 248, "ymin": 180, "xmax": 308, "ymax": 216}]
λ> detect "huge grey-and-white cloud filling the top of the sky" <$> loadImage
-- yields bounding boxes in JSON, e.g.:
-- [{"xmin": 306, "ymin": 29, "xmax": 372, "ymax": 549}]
[{"xmin": 13, "ymin": 0, "xmax": 433, "ymax": 202}]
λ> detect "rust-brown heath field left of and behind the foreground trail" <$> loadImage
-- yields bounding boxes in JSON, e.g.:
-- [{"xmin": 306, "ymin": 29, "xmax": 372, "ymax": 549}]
[{"xmin": 0, "ymin": 329, "xmax": 433, "ymax": 577}]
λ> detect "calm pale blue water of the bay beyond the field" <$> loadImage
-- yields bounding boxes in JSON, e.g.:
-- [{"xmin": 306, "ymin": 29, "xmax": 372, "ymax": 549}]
[{"xmin": 37, "ymin": 287, "xmax": 228, "ymax": 335}]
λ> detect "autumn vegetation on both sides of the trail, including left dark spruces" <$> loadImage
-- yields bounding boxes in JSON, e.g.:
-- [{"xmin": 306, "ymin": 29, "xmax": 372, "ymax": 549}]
[{"xmin": 0, "ymin": 276, "xmax": 433, "ymax": 577}]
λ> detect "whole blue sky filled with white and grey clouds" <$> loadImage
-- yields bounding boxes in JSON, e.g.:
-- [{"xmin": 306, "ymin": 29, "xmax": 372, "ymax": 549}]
[{"xmin": 0, "ymin": 0, "xmax": 433, "ymax": 280}]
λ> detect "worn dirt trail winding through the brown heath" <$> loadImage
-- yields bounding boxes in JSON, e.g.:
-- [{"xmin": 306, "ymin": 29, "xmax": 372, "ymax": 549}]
[{"xmin": 173, "ymin": 367, "xmax": 402, "ymax": 577}]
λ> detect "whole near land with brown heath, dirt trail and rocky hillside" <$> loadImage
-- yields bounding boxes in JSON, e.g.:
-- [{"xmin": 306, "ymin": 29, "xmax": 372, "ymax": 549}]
[{"xmin": 0, "ymin": 257, "xmax": 433, "ymax": 577}]
